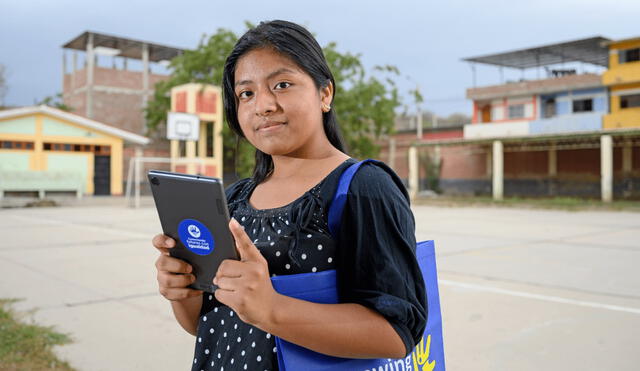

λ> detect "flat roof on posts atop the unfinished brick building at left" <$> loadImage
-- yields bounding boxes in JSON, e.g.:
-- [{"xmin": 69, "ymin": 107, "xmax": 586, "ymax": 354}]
[{"xmin": 62, "ymin": 31, "xmax": 184, "ymax": 62}]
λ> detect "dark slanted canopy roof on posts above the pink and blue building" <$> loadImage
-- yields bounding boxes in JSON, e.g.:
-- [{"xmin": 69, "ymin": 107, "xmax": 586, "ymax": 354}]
[{"xmin": 463, "ymin": 36, "xmax": 611, "ymax": 69}]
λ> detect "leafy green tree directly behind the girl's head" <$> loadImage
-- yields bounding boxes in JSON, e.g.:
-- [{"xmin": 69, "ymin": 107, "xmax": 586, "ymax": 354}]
[{"xmin": 145, "ymin": 23, "xmax": 400, "ymax": 177}]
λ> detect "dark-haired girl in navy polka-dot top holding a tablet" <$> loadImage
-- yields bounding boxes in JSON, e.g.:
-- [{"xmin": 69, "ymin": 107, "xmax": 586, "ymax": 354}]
[{"xmin": 153, "ymin": 21, "xmax": 426, "ymax": 370}]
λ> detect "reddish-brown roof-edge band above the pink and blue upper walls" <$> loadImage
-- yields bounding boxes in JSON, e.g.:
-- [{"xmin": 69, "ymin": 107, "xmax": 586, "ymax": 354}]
[{"xmin": 467, "ymin": 73, "xmax": 604, "ymax": 100}]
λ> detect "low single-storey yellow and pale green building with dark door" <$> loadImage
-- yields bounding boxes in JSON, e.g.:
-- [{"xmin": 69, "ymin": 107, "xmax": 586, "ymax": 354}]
[{"xmin": 0, "ymin": 106, "xmax": 149, "ymax": 198}]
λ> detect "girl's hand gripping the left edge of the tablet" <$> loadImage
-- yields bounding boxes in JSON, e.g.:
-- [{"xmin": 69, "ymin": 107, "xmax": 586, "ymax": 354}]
[{"xmin": 151, "ymin": 234, "xmax": 202, "ymax": 301}]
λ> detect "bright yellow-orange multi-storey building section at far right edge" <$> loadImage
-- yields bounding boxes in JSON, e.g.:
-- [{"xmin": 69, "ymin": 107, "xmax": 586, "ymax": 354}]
[{"xmin": 602, "ymin": 37, "xmax": 640, "ymax": 129}]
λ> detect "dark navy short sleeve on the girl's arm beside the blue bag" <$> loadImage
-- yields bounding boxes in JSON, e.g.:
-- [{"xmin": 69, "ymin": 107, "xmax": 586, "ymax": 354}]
[{"xmin": 337, "ymin": 163, "xmax": 427, "ymax": 354}]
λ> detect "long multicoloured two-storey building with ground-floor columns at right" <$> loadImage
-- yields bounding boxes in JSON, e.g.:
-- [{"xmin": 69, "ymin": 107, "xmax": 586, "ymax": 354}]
[{"xmin": 383, "ymin": 37, "xmax": 640, "ymax": 200}]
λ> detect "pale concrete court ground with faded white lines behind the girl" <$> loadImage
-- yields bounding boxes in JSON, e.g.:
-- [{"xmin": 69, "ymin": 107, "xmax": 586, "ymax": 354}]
[{"xmin": 0, "ymin": 200, "xmax": 640, "ymax": 371}]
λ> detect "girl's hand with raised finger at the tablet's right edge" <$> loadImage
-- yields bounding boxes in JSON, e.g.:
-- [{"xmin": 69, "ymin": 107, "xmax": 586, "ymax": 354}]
[{"xmin": 213, "ymin": 219, "xmax": 278, "ymax": 328}]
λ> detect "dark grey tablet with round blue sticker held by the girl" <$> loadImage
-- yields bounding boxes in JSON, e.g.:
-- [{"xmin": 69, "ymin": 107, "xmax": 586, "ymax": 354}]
[{"xmin": 147, "ymin": 170, "xmax": 238, "ymax": 292}]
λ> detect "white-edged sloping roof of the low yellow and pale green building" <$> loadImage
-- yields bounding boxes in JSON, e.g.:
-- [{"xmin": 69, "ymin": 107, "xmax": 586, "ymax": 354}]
[{"xmin": 0, "ymin": 105, "xmax": 151, "ymax": 145}]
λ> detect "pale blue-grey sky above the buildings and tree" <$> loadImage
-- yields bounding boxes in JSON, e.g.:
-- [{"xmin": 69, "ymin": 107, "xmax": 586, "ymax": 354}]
[{"xmin": 0, "ymin": 0, "xmax": 640, "ymax": 116}]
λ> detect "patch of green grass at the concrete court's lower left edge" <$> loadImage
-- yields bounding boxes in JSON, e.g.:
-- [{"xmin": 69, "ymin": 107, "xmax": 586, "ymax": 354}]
[{"xmin": 0, "ymin": 299, "xmax": 73, "ymax": 371}]
